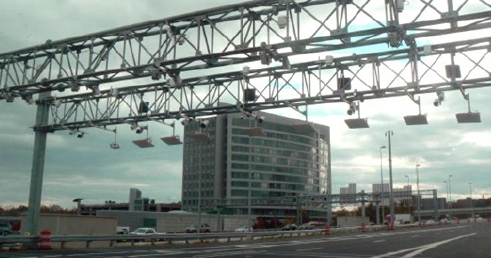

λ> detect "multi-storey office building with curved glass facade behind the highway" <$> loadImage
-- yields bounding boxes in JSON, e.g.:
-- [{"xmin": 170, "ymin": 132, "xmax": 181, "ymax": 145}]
[{"xmin": 182, "ymin": 112, "xmax": 331, "ymax": 217}]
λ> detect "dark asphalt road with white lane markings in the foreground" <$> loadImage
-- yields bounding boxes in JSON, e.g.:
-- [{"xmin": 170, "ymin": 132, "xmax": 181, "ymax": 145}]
[{"xmin": 0, "ymin": 222, "xmax": 491, "ymax": 258}]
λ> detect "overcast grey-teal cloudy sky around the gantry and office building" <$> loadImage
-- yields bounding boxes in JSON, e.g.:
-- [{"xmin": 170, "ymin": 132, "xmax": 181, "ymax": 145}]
[{"xmin": 0, "ymin": 0, "xmax": 491, "ymax": 207}]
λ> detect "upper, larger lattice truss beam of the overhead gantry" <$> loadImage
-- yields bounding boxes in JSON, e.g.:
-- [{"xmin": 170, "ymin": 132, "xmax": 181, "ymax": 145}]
[{"xmin": 0, "ymin": 0, "xmax": 491, "ymax": 99}]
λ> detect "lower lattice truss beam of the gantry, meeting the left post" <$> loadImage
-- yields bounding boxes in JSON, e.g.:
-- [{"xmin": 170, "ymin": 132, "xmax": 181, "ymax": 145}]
[{"xmin": 39, "ymin": 38, "xmax": 491, "ymax": 131}]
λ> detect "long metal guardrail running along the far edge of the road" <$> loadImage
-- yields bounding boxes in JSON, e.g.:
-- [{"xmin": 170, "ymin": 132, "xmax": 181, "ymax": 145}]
[{"xmin": 0, "ymin": 224, "xmax": 464, "ymax": 251}]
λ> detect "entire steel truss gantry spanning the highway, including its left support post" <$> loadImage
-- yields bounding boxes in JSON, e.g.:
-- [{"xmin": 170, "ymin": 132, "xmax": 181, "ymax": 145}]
[{"xmin": 0, "ymin": 0, "xmax": 491, "ymax": 234}]
